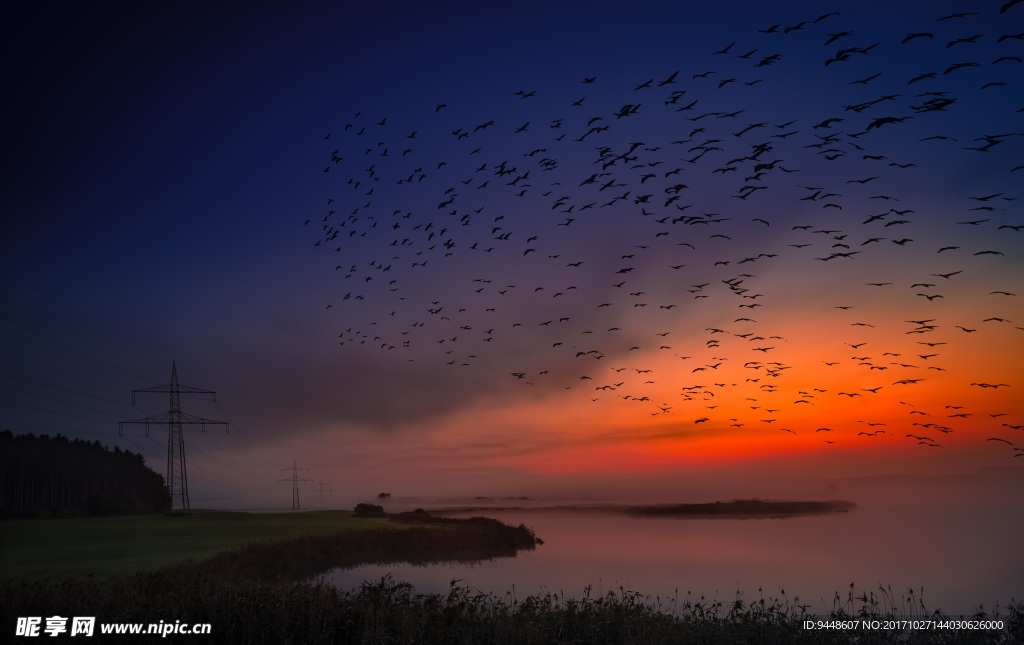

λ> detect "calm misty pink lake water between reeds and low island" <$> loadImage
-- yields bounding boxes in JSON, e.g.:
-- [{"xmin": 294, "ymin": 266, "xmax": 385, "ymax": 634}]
[{"xmin": 329, "ymin": 469, "xmax": 1024, "ymax": 615}]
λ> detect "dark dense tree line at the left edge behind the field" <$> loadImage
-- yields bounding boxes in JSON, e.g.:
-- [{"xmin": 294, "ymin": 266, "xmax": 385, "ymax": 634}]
[{"xmin": 0, "ymin": 430, "xmax": 170, "ymax": 517}]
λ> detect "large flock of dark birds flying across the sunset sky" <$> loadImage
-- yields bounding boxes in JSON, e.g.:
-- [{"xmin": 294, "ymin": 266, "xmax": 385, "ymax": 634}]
[{"xmin": 304, "ymin": 0, "xmax": 1024, "ymax": 457}]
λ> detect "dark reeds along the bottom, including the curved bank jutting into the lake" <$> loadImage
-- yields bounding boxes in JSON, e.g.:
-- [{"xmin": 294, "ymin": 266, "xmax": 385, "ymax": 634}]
[{"xmin": 0, "ymin": 518, "xmax": 1024, "ymax": 644}]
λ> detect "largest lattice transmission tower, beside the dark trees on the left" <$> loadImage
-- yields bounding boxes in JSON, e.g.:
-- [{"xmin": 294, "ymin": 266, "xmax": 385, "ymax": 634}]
[{"xmin": 118, "ymin": 361, "xmax": 227, "ymax": 515}]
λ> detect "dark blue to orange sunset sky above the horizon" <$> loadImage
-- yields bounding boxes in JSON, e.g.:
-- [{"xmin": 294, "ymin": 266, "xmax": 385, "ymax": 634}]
[{"xmin": 0, "ymin": 1, "xmax": 1024, "ymax": 508}]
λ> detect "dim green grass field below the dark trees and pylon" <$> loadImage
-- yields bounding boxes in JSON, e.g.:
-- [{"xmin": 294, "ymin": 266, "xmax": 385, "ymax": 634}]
[{"xmin": 0, "ymin": 511, "xmax": 393, "ymax": 579}]
